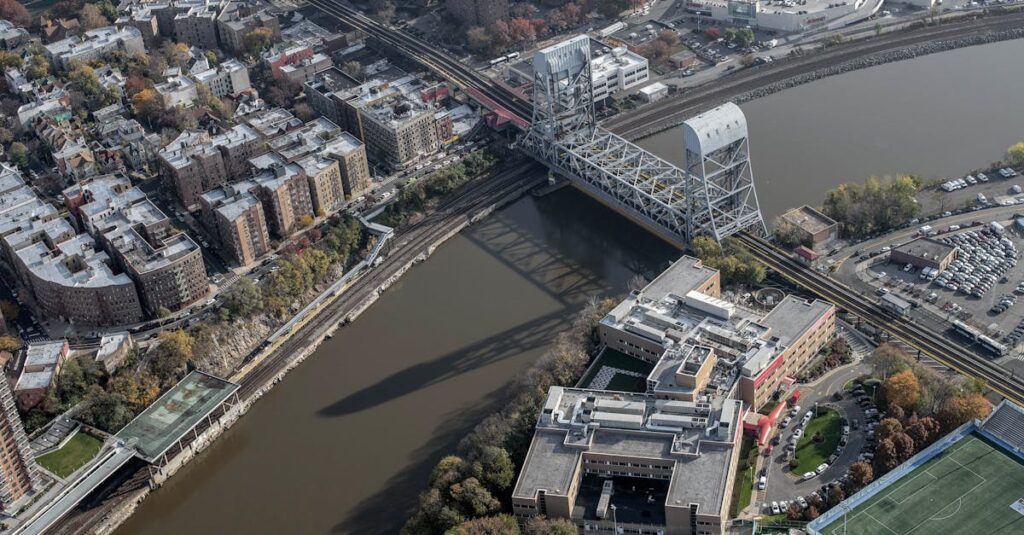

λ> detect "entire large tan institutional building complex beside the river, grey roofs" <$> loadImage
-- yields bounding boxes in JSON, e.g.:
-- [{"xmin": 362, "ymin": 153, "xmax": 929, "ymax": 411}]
[{"xmin": 512, "ymin": 256, "xmax": 836, "ymax": 535}]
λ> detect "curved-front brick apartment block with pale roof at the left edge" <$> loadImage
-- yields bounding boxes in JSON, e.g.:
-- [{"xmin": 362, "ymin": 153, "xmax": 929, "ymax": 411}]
[{"xmin": 0, "ymin": 165, "xmax": 143, "ymax": 326}]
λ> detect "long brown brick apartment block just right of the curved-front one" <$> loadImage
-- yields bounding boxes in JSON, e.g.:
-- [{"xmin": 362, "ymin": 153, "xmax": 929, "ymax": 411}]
[{"xmin": 65, "ymin": 175, "xmax": 209, "ymax": 315}]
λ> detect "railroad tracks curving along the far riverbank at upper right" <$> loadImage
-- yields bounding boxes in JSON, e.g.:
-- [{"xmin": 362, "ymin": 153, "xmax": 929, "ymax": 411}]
[{"xmin": 603, "ymin": 11, "xmax": 1024, "ymax": 136}]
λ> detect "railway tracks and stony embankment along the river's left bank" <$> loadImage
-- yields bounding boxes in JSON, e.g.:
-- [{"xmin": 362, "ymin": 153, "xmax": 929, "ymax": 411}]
[{"xmin": 61, "ymin": 166, "xmax": 544, "ymax": 534}]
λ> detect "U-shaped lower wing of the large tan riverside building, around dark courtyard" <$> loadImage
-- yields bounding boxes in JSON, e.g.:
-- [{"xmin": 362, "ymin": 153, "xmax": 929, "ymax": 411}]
[{"xmin": 512, "ymin": 386, "xmax": 745, "ymax": 535}]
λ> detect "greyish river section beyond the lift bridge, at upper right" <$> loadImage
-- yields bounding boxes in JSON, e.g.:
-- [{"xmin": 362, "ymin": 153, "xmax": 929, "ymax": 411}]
[{"xmin": 639, "ymin": 40, "xmax": 1024, "ymax": 219}]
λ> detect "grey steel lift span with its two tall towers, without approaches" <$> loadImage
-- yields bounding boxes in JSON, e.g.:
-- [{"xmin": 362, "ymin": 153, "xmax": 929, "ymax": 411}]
[{"xmin": 518, "ymin": 36, "xmax": 767, "ymax": 247}]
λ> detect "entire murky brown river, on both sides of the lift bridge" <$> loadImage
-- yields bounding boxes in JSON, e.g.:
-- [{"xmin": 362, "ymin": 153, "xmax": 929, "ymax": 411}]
[{"xmin": 118, "ymin": 41, "xmax": 1024, "ymax": 535}]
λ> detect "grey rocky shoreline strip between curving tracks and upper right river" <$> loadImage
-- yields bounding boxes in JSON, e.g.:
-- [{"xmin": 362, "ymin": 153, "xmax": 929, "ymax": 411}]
[{"xmin": 625, "ymin": 28, "xmax": 1024, "ymax": 141}]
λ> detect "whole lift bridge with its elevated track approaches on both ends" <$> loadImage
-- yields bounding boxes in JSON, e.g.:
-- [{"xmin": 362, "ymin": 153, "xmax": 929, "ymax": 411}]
[{"xmin": 310, "ymin": 0, "xmax": 1024, "ymax": 403}]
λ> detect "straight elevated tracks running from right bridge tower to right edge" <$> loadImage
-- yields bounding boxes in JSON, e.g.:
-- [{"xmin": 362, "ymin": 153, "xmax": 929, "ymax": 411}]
[{"xmin": 737, "ymin": 233, "xmax": 1024, "ymax": 403}]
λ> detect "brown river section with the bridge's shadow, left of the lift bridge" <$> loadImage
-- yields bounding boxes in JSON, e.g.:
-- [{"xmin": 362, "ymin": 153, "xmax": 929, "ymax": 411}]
[{"xmin": 118, "ymin": 189, "xmax": 678, "ymax": 534}]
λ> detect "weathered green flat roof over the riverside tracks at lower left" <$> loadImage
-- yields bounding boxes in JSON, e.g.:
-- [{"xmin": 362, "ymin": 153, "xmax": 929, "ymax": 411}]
[{"xmin": 116, "ymin": 371, "xmax": 239, "ymax": 462}]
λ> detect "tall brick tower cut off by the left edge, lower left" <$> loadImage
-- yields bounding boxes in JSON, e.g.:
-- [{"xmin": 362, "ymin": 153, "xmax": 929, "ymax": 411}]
[{"xmin": 0, "ymin": 371, "xmax": 42, "ymax": 508}]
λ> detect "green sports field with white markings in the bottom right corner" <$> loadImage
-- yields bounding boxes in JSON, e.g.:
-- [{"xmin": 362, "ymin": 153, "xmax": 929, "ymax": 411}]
[{"xmin": 821, "ymin": 435, "xmax": 1024, "ymax": 535}]
